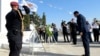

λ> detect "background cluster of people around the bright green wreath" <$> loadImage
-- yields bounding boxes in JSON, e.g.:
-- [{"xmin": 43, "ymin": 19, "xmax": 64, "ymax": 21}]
[{"xmin": 38, "ymin": 23, "xmax": 58, "ymax": 42}]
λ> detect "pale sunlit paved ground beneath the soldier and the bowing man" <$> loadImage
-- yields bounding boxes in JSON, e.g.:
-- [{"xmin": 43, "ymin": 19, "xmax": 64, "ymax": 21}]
[{"xmin": 0, "ymin": 31, "xmax": 100, "ymax": 56}]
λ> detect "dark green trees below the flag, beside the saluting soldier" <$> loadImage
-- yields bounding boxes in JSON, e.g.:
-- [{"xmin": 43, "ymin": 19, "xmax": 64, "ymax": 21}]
[{"xmin": 24, "ymin": 12, "xmax": 46, "ymax": 30}]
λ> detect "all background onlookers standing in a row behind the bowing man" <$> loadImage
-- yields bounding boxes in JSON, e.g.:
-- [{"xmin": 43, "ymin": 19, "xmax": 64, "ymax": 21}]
[{"xmin": 38, "ymin": 15, "xmax": 100, "ymax": 45}]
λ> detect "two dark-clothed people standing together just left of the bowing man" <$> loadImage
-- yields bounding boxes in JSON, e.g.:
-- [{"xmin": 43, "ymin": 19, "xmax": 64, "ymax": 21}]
[{"xmin": 61, "ymin": 19, "xmax": 77, "ymax": 44}]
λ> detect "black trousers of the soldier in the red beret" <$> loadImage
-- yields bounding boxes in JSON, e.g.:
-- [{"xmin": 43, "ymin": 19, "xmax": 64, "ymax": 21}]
[{"xmin": 7, "ymin": 31, "xmax": 22, "ymax": 56}]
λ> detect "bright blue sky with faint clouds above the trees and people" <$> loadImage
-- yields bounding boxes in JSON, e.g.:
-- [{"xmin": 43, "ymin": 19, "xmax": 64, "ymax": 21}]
[{"xmin": 19, "ymin": 0, "xmax": 100, "ymax": 28}]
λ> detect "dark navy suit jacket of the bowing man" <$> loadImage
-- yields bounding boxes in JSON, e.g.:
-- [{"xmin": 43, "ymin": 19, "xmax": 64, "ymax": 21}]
[{"xmin": 77, "ymin": 14, "xmax": 89, "ymax": 33}]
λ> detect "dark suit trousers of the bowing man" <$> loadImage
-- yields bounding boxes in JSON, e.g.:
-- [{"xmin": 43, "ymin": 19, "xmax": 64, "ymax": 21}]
[{"xmin": 81, "ymin": 33, "xmax": 90, "ymax": 56}]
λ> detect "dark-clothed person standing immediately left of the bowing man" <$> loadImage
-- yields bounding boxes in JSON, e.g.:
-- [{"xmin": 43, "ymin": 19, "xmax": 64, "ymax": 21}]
[{"xmin": 69, "ymin": 19, "xmax": 77, "ymax": 45}]
